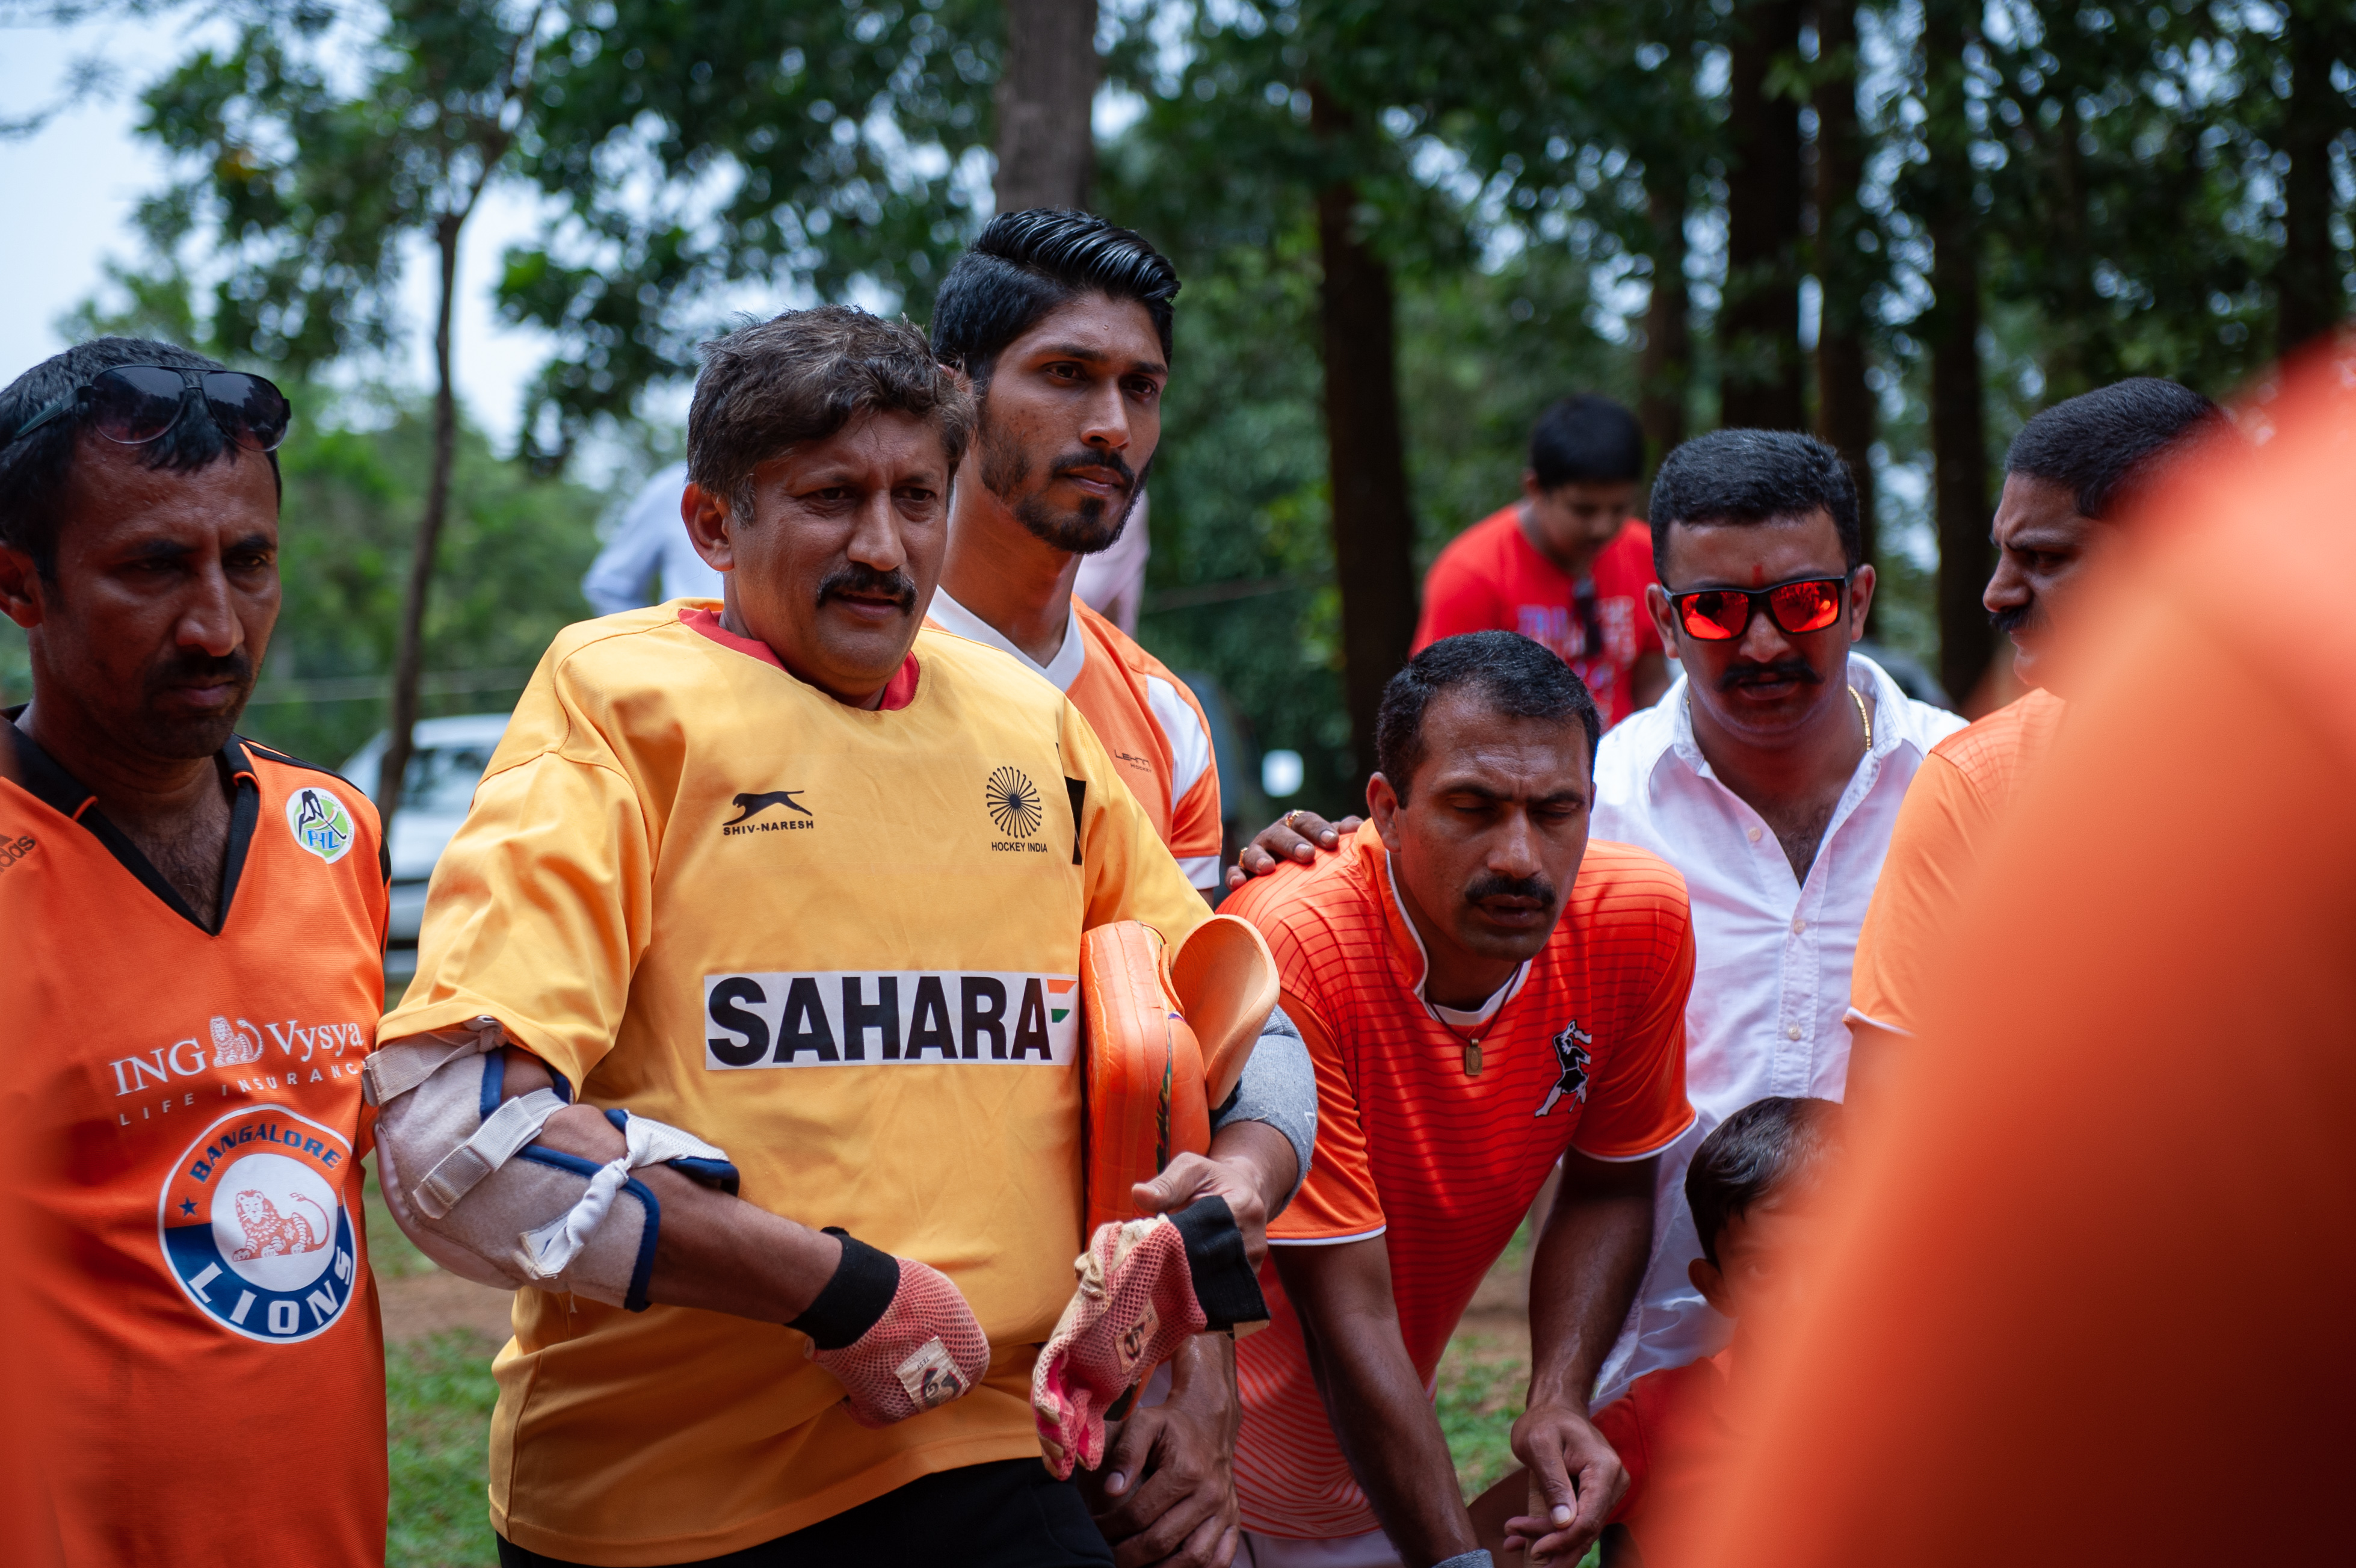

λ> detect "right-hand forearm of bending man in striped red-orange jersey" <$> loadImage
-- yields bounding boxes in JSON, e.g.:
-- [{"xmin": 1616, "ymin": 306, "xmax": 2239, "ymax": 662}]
[{"xmin": 1529, "ymin": 1155, "xmax": 1659, "ymax": 1412}]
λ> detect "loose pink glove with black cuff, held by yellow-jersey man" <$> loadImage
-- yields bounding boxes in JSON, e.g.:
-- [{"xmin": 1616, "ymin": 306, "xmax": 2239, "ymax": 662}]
[{"xmin": 1032, "ymin": 1198, "xmax": 1268, "ymax": 1481}]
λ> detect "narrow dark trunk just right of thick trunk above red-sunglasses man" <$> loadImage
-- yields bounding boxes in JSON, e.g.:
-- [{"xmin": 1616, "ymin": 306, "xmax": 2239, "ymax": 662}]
[{"xmin": 1814, "ymin": 0, "xmax": 1875, "ymax": 561}]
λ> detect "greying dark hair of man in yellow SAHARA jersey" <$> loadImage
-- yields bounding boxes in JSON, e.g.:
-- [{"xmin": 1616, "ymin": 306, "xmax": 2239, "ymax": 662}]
[{"xmin": 688, "ymin": 304, "xmax": 973, "ymax": 516}]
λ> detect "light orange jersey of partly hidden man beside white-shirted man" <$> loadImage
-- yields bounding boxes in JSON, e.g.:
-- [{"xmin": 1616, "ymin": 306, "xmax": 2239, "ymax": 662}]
[{"xmin": 1849, "ymin": 691, "xmax": 2062, "ymax": 1035}]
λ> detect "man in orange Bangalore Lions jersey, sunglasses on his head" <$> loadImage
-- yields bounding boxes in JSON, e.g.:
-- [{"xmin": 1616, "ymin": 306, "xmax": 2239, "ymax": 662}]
[{"xmin": 0, "ymin": 337, "xmax": 386, "ymax": 1568}]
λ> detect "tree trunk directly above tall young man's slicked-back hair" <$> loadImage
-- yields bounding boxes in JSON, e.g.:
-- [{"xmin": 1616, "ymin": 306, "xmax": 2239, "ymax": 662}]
[{"xmin": 995, "ymin": 0, "xmax": 1103, "ymax": 212}]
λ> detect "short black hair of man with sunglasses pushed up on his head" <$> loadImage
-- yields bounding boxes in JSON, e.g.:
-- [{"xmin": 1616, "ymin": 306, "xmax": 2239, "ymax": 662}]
[{"xmin": 0, "ymin": 337, "xmax": 285, "ymax": 582}]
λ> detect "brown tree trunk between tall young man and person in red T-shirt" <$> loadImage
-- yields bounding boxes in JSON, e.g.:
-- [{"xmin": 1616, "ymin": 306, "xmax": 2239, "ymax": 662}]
[{"xmin": 1310, "ymin": 90, "xmax": 1416, "ymax": 776}]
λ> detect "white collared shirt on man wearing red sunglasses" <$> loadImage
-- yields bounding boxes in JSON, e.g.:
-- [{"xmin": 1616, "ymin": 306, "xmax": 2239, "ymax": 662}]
[{"xmin": 1593, "ymin": 653, "xmax": 1965, "ymax": 1403}]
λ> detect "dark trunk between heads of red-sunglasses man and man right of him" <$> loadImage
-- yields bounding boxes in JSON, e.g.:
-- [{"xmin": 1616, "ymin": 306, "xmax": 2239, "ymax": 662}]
[{"xmin": 1922, "ymin": 0, "xmax": 1996, "ymax": 703}]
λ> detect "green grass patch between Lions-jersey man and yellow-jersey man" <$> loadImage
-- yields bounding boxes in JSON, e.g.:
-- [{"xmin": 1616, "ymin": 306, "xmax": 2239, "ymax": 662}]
[{"xmin": 384, "ymin": 1332, "xmax": 499, "ymax": 1568}]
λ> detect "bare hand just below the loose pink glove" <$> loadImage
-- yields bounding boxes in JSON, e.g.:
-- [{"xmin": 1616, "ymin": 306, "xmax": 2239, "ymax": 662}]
[{"xmin": 1084, "ymin": 1335, "xmax": 1242, "ymax": 1568}]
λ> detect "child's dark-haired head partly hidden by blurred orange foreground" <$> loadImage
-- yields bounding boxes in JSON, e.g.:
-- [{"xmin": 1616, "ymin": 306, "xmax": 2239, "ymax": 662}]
[{"xmin": 1685, "ymin": 1099, "xmax": 1842, "ymax": 1323}]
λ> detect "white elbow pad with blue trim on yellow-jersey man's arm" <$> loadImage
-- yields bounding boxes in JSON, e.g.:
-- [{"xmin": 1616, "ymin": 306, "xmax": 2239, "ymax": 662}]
[{"xmin": 360, "ymin": 1019, "xmax": 738, "ymax": 1311}]
